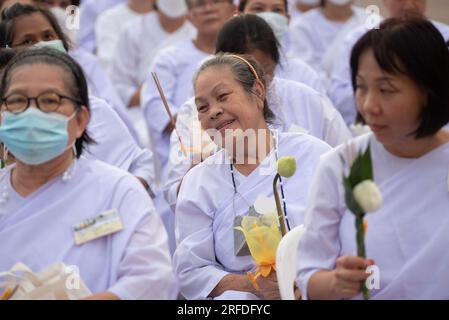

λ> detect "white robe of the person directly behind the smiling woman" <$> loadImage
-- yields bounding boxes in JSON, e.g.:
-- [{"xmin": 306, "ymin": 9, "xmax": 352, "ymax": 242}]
[{"xmin": 164, "ymin": 78, "xmax": 351, "ymax": 208}]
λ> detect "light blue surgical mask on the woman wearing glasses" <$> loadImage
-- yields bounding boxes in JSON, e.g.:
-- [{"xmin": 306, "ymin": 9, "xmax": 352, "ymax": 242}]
[{"xmin": 0, "ymin": 107, "xmax": 76, "ymax": 165}]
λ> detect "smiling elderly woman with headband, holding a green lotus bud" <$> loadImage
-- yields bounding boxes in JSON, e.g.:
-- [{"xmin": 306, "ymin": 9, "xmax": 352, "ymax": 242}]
[{"xmin": 173, "ymin": 54, "xmax": 330, "ymax": 299}]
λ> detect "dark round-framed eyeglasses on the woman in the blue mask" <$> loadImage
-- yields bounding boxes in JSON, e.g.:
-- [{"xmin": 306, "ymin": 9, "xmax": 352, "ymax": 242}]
[{"xmin": 1, "ymin": 92, "xmax": 82, "ymax": 114}]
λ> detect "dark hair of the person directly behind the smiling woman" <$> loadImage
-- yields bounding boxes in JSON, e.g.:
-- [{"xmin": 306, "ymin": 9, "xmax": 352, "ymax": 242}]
[{"xmin": 215, "ymin": 14, "xmax": 280, "ymax": 64}]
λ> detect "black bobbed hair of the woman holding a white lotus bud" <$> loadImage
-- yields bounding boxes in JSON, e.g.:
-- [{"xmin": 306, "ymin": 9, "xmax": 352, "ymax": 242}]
[{"xmin": 350, "ymin": 17, "xmax": 449, "ymax": 138}]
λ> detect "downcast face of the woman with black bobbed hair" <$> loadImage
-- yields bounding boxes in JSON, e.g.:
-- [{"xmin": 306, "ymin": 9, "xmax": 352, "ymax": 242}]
[{"xmin": 356, "ymin": 50, "xmax": 426, "ymax": 148}]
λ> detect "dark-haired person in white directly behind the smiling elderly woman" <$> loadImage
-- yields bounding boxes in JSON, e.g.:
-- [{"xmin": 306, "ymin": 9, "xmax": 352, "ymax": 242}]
[{"xmin": 164, "ymin": 14, "xmax": 351, "ymax": 207}]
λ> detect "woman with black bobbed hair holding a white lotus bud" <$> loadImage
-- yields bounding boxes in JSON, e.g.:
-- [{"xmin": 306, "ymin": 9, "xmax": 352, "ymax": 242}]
[{"xmin": 298, "ymin": 19, "xmax": 449, "ymax": 299}]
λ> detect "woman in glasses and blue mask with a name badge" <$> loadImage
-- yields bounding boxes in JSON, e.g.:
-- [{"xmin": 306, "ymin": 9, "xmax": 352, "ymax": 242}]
[{"xmin": 0, "ymin": 49, "xmax": 173, "ymax": 299}]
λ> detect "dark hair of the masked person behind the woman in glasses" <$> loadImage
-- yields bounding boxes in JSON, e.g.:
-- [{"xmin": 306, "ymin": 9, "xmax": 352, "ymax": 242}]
[{"xmin": 0, "ymin": 3, "xmax": 71, "ymax": 51}]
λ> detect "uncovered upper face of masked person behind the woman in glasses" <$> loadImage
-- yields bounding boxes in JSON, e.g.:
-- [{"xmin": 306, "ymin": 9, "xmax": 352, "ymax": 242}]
[{"xmin": 12, "ymin": 12, "xmax": 59, "ymax": 50}]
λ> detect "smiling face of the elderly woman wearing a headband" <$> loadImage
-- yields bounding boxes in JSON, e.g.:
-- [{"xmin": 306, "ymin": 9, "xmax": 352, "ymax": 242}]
[{"xmin": 195, "ymin": 66, "xmax": 265, "ymax": 148}]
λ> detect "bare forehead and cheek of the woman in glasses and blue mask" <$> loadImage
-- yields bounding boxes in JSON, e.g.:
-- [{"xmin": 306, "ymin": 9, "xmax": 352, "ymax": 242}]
[{"xmin": 5, "ymin": 63, "xmax": 88, "ymax": 151}]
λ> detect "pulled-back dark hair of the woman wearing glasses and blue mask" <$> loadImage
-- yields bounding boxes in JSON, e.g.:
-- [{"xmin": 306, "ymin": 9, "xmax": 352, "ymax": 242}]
[{"xmin": 0, "ymin": 48, "xmax": 95, "ymax": 157}]
